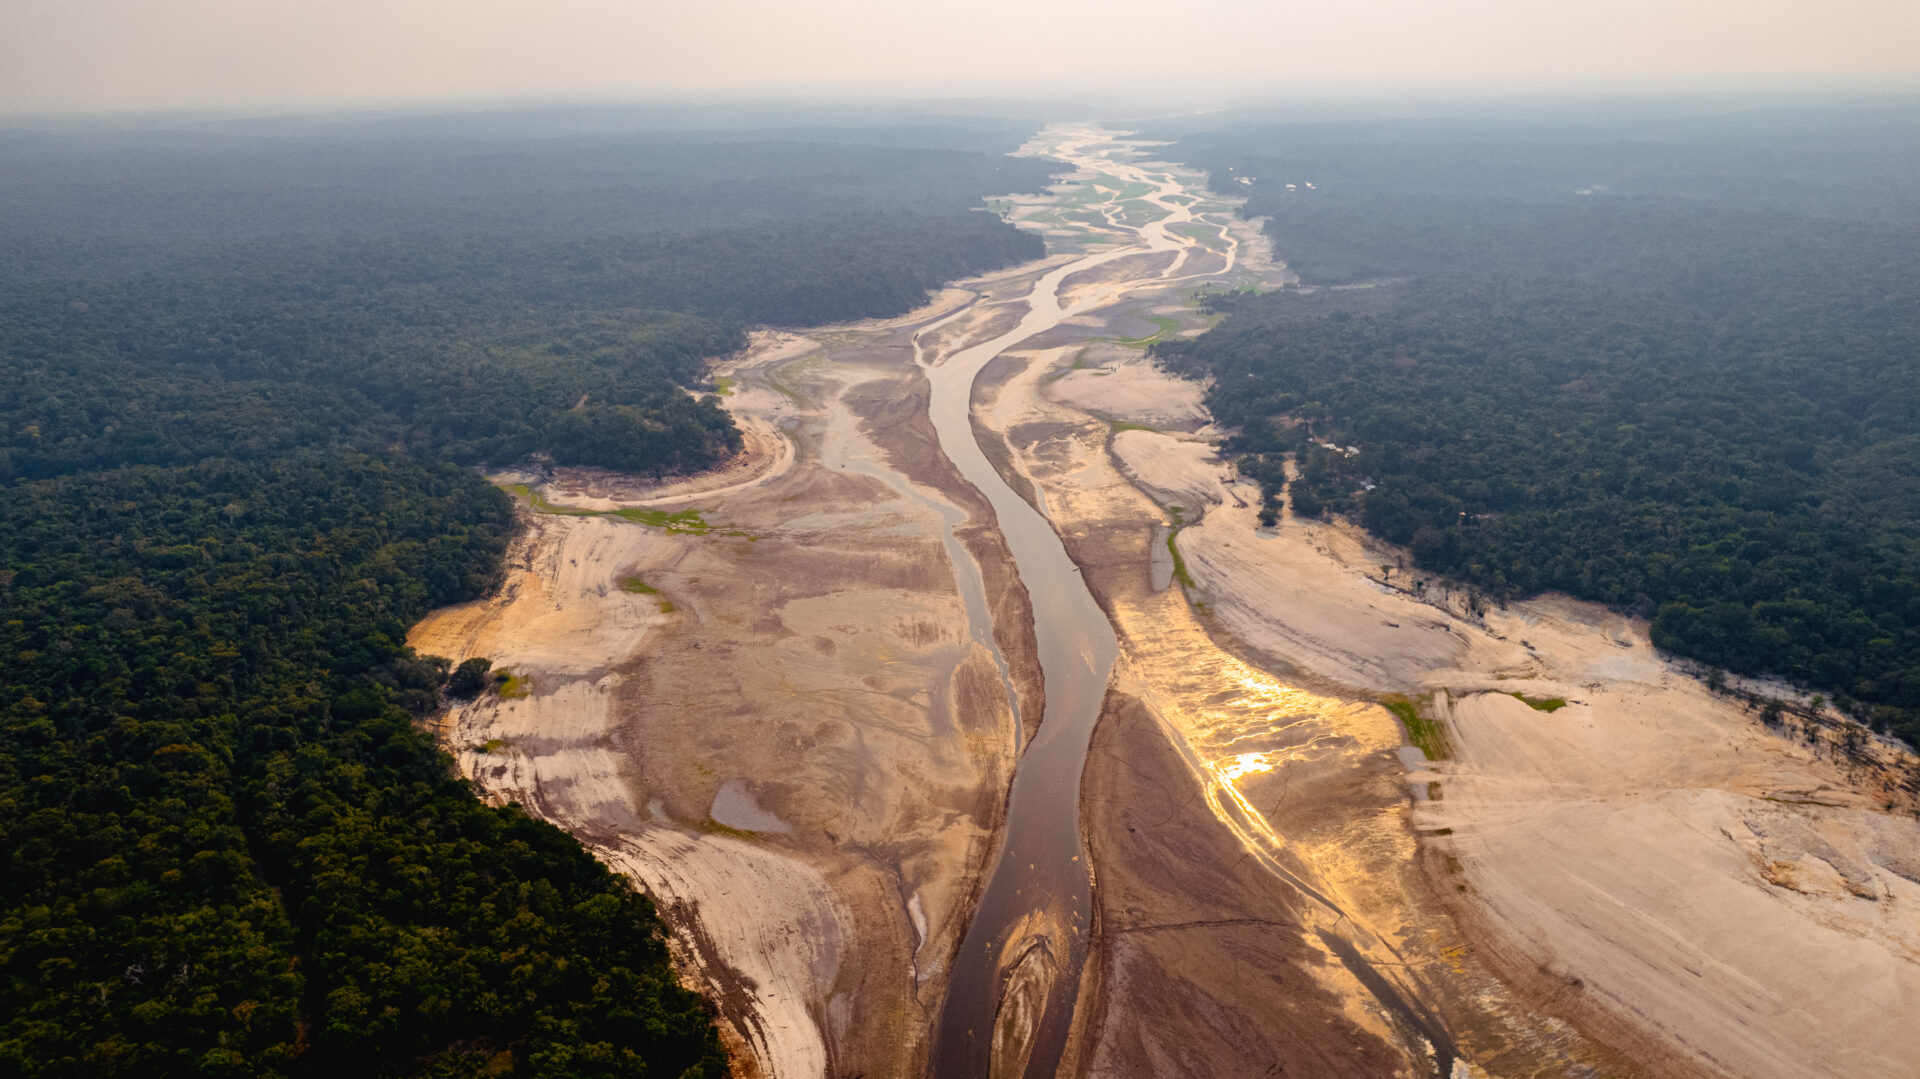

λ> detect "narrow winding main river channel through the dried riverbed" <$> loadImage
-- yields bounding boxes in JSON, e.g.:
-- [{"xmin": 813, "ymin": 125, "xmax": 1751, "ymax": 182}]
[{"xmin": 927, "ymin": 127, "xmax": 1192, "ymax": 1079}]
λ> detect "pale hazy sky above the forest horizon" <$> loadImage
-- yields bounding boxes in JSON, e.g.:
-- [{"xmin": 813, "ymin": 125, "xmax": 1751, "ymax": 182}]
[{"xmin": 0, "ymin": 0, "xmax": 1920, "ymax": 113}]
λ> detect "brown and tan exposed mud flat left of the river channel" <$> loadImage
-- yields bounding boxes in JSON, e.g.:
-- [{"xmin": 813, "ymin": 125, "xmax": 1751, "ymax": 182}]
[{"xmin": 411, "ymin": 282, "xmax": 1039, "ymax": 1077}]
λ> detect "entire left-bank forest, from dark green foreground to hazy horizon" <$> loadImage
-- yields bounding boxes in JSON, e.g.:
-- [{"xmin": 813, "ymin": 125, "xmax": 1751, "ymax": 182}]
[{"xmin": 0, "ymin": 107, "xmax": 1046, "ymax": 1077}]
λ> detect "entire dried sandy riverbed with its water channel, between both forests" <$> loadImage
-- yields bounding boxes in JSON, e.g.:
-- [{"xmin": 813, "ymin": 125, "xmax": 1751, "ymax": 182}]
[{"xmin": 411, "ymin": 125, "xmax": 1920, "ymax": 1077}]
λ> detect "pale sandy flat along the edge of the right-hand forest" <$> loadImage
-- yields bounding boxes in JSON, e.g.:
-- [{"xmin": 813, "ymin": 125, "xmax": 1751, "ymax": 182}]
[{"xmin": 1082, "ymin": 408, "xmax": 1920, "ymax": 1079}]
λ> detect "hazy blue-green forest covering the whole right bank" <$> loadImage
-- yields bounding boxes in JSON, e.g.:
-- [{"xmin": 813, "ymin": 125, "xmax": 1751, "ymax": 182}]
[{"xmin": 1156, "ymin": 102, "xmax": 1920, "ymax": 741}]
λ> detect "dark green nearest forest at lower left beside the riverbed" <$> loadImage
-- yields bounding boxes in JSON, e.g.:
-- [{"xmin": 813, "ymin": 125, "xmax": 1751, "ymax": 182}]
[{"xmin": 0, "ymin": 453, "xmax": 726, "ymax": 1075}]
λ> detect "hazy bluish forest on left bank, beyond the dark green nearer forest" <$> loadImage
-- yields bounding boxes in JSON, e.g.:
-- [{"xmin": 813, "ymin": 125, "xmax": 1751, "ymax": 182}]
[{"xmin": 0, "ymin": 131, "xmax": 1048, "ymax": 480}]
